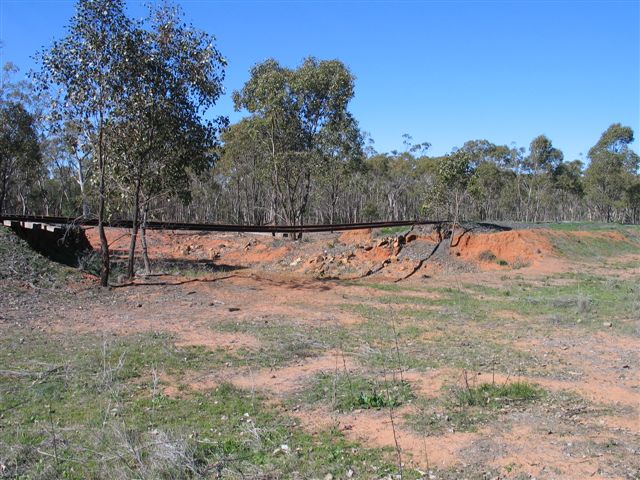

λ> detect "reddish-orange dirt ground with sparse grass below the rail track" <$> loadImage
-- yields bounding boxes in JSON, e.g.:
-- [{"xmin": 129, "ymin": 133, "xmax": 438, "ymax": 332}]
[{"xmin": 4, "ymin": 225, "xmax": 640, "ymax": 480}]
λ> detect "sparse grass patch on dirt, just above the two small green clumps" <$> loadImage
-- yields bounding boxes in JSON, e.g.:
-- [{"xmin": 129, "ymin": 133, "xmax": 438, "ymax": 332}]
[{"xmin": 345, "ymin": 300, "xmax": 553, "ymax": 376}]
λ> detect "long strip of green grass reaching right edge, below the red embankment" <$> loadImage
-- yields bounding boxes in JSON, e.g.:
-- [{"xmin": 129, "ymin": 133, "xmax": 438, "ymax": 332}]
[{"xmin": 368, "ymin": 273, "xmax": 640, "ymax": 339}]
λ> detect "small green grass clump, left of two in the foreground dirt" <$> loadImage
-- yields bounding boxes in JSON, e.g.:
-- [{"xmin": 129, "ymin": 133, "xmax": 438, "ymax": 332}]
[{"xmin": 301, "ymin": 372, "xmax": 414, "ymax": 412}]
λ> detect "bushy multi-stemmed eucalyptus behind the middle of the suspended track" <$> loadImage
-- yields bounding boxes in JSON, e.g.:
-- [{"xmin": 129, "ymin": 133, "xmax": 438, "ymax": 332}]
[{"xmin": 233, "ymin": 57, "xmax": 354, "ymax": 229}]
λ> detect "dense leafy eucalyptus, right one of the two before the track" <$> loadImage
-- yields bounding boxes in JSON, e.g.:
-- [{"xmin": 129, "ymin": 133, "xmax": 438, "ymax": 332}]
[{"xmin": 113, "ymin": 3, "xmax": 226, "ymax": 277}]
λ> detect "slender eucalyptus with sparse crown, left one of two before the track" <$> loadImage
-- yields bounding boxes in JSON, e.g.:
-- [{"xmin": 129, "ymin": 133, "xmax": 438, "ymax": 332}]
[{"xmin": 39, "ymin": 0, "xmax": 132, "ymax": 286}]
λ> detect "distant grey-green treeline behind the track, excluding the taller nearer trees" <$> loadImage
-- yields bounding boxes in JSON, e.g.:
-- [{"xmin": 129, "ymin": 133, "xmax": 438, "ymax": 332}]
[{"xmin": 206, "ymin": 128, "xmax": 640, "ymax": 228}]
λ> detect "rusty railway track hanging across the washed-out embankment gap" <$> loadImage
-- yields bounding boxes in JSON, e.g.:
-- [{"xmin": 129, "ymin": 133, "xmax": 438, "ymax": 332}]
[{"xmin": 0, "ymin": 215, "xmax": 445, "ymax": 235}]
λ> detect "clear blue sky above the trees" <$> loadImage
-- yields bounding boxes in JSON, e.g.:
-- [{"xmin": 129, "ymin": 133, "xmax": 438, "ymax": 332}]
[{"xmin": 0, "ymin": 0, "xmax": 640, "ymax": 160}]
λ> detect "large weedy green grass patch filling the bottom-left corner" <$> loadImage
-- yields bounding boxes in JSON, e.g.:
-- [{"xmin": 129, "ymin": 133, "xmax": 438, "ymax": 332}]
[{"xmin": 0, "ymin": 332, "xmax": 415, "ymax": 479}]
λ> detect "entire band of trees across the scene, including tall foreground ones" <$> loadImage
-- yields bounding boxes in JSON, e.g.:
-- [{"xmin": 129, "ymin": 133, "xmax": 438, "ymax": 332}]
[{"xmin": 0, "ymin": 0, "xmax": 640, "ymax": 283}]
